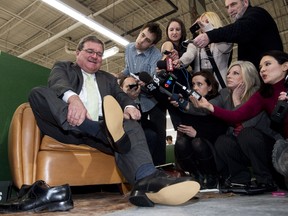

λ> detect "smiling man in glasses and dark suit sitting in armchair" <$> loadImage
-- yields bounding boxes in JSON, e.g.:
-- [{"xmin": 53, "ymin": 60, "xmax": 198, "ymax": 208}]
[{"xmin": 29, "ymin": 36, "xmax": 199, "ymax": 206}]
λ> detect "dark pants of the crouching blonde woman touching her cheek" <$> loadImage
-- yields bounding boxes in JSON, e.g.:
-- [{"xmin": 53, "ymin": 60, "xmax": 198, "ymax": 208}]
[{"xmin": 215, "ymin": 128, "xmax": 275, "ymax": 183}]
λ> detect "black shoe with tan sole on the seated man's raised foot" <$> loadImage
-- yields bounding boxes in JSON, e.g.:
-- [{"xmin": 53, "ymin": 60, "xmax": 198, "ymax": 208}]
[{"xmin": 102, "ymin": 95, "xmax": 131, "ymax": 154}]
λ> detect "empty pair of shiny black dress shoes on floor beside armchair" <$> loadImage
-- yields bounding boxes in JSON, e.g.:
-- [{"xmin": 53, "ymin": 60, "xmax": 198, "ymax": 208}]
[{"xmin": 0, "ymin": 181, "xmax": 73, "ymax": 213}]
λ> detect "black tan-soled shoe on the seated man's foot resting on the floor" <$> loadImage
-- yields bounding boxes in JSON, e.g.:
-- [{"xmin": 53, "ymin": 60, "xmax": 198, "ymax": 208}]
[{"xmin": 129, "ymin": 170, "xmax": 200, "ymax": 207}]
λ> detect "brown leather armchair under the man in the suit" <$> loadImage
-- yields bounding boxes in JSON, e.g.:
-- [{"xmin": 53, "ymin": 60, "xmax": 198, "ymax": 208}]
[{"xmin": 8, "ymin": 103, "xmax": 127, "ymax": 193}]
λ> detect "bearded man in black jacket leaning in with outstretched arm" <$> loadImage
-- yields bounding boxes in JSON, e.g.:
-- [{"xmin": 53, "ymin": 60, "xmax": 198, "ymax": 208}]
[{"xmin": 194, "ymin": 0, "xmax": 283, "ymax": 68}]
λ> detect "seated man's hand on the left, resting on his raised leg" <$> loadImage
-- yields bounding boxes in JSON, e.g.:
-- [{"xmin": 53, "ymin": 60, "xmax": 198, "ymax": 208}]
[{"xmin": 67, "ymin": 95, "xmax": 89, "ymax": 126}]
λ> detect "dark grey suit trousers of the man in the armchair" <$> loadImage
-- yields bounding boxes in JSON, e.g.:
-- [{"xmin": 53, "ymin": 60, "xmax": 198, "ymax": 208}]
[{"xmin": 29, "ymin": 87, "xmax": 153, "ymax": 185}]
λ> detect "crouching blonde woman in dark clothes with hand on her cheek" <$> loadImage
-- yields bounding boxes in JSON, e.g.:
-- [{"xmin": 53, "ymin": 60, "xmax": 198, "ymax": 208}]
[{"xmin": 190, "ymin": 61, "xmax": 281, "ymax": 194}]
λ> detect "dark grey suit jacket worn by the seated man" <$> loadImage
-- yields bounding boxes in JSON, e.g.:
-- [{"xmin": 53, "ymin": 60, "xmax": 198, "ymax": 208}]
[{"xmin": 48, "ymin": 61, "xmax": 136, "ymax": 109}]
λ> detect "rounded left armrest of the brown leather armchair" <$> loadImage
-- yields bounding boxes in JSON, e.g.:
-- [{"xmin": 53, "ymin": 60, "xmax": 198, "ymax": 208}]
[{"xmin": 8, "ymin": 103, "xmax": 41, "ymax": 188}]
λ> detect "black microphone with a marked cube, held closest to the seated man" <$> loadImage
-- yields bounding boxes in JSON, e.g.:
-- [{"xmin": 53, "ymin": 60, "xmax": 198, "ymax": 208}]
[{"xmin": 139, "ymin": 71, "xmax": 188, "ymax": 108}]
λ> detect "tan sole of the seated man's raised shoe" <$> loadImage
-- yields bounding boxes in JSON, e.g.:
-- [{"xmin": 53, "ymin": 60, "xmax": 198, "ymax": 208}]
[{"xmin": 103, "ymin": 95, "xmax": 125, "ymax": 142}]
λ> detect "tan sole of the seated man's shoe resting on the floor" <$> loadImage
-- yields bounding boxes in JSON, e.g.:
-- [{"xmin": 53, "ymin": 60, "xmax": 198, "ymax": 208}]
[{"xmin": 146, "ymin": 181, "xmax": 200, "ymax": 205}]
